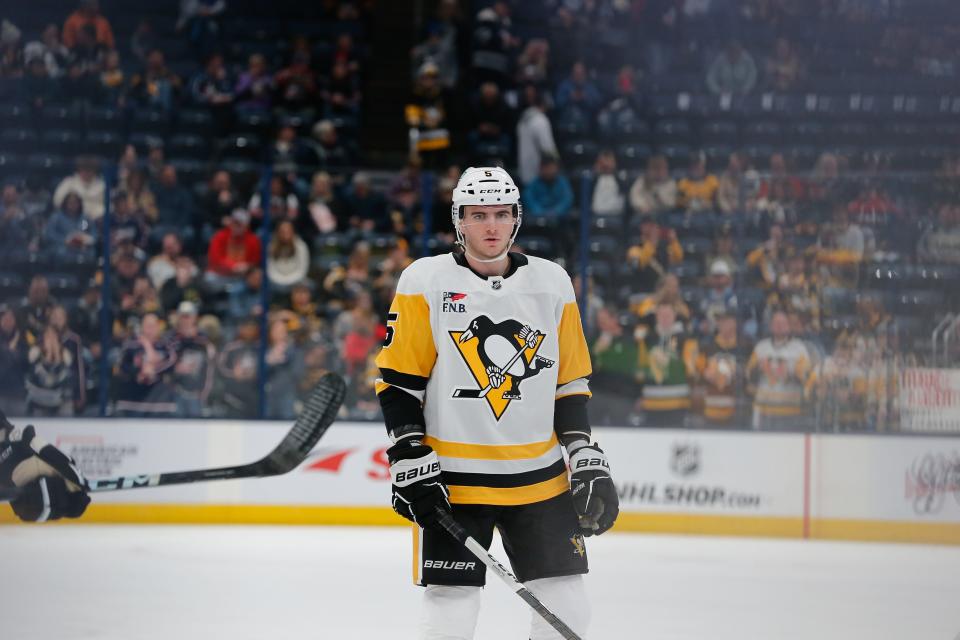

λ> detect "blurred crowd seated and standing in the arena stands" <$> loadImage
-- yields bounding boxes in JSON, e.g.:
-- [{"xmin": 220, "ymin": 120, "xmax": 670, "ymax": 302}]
[{"xmin": 0, "ymin": 0, "xmax": 960, "ymax": 429}]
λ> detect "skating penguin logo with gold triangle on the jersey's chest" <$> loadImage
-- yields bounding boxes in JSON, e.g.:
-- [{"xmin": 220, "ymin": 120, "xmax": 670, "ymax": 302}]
[{"xmin": 450, "ymin": 316, "xmax": 554, "ymax": 420}]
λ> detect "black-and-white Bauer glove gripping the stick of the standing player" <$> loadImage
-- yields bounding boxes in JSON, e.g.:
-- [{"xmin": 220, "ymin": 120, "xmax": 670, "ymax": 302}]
[{"xmin": 387, "ymin": 438, "xmax": 450, "ymax": 529}]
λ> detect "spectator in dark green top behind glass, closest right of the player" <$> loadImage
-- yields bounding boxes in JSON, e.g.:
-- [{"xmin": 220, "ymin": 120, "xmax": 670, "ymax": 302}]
[{"xmin": 590, "ymin": 306, "xmax": 642, "ymax": 425}]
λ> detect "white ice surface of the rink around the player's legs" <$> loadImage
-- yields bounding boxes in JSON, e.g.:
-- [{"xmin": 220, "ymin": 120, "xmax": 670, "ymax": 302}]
[{"xmin": 0, "ymin": 526, "xmax": 960, "ymax": 640}]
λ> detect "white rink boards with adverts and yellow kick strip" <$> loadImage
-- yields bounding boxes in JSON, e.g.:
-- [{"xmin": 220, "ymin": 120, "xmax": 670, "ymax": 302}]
[{"xmin": 0, "ymin": 419, "xmax": 960, "ymax": 544}]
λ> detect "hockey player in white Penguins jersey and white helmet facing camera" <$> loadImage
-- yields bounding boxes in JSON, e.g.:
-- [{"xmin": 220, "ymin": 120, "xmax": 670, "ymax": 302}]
[{"xmin": 377, "ymin": 167, "xmax": 619, "ymax": 640}]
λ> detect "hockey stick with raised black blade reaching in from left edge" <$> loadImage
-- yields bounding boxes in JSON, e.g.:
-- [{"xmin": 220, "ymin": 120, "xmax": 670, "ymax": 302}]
[{"xmin": 0, "ymin": 373, "xmax": 346, "ymax": 501}]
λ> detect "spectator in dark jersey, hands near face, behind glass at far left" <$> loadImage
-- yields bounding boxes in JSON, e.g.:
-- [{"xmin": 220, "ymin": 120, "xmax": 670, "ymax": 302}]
[{"xmin": 24, "ymin": 326, "xmax": 74, "ymax": 416}]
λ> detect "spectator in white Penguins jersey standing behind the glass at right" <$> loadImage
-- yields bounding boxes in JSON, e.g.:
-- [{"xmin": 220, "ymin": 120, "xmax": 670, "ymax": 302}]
[{"xmin": 746, "ymin": 311, "xmax": 811, "ymax": 430}]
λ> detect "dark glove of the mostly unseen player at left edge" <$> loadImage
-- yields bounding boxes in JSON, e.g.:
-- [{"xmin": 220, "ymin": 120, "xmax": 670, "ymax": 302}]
[{"xmin": 0, "ymin": 413, "xmax": 90, "ymax": 522}]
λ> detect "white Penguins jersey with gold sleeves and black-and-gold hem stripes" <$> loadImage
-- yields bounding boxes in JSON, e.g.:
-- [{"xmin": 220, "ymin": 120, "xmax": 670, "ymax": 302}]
[{"xmin": 377, "ymin": 254, "xmax": 591, "ymax": 505}]
